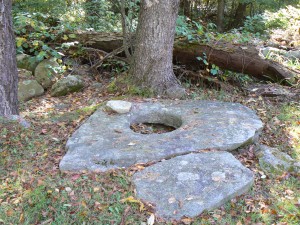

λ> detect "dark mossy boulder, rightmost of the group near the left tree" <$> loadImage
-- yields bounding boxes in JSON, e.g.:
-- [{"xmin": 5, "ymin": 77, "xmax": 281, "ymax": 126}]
[{"xmin": 51, "ymin": 75, "xmax": 84, "ymax": 97}]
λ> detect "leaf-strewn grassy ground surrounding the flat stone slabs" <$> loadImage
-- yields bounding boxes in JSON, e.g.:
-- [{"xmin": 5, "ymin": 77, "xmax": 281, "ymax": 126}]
[{"xmin": 0, "ymin": 71, "xmax": 300, "ymax": 225}]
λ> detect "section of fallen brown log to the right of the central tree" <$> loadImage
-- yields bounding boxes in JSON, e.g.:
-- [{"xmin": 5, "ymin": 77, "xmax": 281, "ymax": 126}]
[{"xmin": 173, "ymin": 42, "xmax": 297, "ymax": 84}]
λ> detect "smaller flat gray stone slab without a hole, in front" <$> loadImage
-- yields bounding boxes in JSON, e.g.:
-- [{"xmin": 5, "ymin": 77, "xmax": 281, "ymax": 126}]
[{"xmin": 133, "ymin": 152, "xmax": 254, "ymax": 220}]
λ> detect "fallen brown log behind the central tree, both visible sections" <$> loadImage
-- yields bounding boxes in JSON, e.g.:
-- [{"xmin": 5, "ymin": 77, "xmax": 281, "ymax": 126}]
[{"xmin": 72, "ymin": 32, "xmax": 299, "ymax": 84}]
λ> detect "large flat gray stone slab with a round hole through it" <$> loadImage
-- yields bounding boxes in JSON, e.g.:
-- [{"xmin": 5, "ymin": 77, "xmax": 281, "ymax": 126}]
[{"xmin": 60, "ymin": 101, "xmax": 263, "ymax": 171}]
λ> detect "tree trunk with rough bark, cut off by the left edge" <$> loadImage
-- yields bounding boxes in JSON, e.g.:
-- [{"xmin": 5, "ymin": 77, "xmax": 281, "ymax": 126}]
[{"xmin": 0, "ymin": 0, "xmax": 19, "ymax": 116}]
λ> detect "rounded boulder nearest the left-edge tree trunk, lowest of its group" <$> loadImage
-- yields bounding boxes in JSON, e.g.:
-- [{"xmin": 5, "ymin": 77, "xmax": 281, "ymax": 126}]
[{"xmin": 18, "ymin": 80, "xmax": 44, "ymax": 102}]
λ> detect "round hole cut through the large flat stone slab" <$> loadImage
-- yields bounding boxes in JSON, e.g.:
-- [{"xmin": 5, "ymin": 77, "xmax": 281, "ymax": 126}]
[{"xmin": 130, "ymin": 112, "xmax": 182, "ymax": 134}]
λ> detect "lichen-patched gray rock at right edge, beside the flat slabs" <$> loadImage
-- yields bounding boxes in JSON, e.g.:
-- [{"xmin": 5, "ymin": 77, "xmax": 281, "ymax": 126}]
[{"xmin": 257, "ymin": 145, "xmax": 300, "ymax": 174}]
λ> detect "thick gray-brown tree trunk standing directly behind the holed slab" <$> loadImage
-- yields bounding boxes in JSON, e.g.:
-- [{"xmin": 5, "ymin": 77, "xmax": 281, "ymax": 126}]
[{"xmin": 130, "ymin": 0, "xmax": 185, "ymax": 98}]
